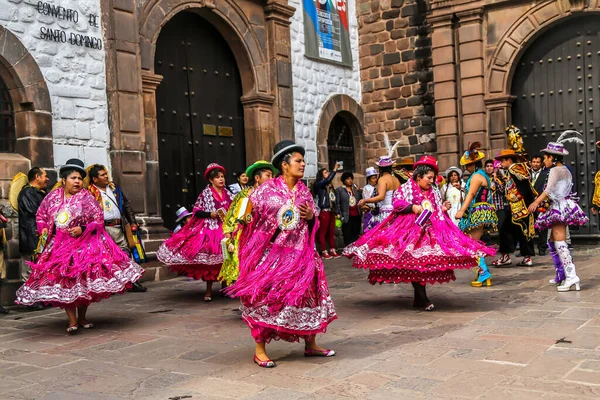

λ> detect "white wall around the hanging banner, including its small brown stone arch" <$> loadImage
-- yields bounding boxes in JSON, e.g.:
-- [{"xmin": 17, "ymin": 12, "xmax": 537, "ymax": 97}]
[{"xmin": 289, "ymin": 0, "xmax": 366, "ymax": 179}]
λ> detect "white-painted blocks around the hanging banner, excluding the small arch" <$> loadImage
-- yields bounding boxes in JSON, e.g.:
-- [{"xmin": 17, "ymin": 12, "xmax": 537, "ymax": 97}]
[{"xmin": 289, "ymin": 0, "xmax": 361, "ymax": 178}]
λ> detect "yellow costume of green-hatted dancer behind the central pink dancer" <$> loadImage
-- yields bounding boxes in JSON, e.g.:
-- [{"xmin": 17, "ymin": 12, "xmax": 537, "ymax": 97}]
[{"xmin": 219, "ymin": 188, "xmax": 250, "ymax": 285}]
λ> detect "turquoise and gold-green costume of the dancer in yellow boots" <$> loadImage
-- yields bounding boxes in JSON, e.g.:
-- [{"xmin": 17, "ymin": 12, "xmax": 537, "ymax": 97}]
[{"xmin": 458, "ymin": 169, "xmax": 498, "ymax": 233}]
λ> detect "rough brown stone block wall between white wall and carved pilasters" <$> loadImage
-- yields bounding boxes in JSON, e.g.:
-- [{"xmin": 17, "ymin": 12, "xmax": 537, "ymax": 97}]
[{"xmin": 357, "ymin": 0, "xmax": 436, "ymax": 162}]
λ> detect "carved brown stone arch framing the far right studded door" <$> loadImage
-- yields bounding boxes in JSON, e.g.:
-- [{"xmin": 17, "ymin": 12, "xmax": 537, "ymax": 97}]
[{"xmin": 485, "ymin": 0, "xmax": 600, "ymax": 154}]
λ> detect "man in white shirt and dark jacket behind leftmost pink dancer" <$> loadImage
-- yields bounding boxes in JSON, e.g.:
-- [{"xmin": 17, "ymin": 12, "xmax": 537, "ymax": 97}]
[{"xmin": 87, "ymin": 164, "xmax": 148, "ymax": 292}]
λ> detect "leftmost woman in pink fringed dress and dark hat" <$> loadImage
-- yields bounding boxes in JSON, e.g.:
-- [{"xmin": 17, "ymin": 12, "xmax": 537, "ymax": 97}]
[{"xmin": 16, "ymin": 159, "xmax": 144, "ymax": 333}]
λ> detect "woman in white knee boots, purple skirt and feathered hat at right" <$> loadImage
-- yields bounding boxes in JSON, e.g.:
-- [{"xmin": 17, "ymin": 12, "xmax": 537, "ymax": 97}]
[{"xmin": 529, "ymin": 130, "xmax": 588, "ymax": 292}]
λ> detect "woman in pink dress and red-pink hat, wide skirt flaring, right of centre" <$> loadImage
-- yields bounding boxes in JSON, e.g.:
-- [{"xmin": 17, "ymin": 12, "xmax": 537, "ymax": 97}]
[{"xmin": 344, "ymin": 156, "xmax": 495, "ymax": 311}]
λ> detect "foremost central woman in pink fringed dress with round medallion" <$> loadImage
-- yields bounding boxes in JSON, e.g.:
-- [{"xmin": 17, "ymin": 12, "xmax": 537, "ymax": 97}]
[{"xmin": 227, "ymin": 140, "xmax": 337, "ymax": 368}]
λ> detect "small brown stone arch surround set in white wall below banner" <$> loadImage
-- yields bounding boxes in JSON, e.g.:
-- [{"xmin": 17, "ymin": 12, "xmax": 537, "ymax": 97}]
[{"xmin": 317, "ymin": 94, "xmax": 367, "ymax": 175}]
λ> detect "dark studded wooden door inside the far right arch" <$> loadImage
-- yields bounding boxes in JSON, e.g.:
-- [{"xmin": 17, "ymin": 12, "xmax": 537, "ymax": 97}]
[{"xmin": 511, "ymin": 16, "xmax": 600, "ymax": 234}]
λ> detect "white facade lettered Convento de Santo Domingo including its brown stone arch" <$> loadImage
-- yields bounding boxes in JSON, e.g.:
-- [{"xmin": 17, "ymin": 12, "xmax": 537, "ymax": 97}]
[{"xmin": 0, "ymin": 0, "xmax": 110, "ymax": 302}]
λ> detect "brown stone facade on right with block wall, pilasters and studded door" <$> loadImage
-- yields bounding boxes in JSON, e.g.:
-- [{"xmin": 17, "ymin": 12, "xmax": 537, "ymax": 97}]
[{"xmin": 358, "ymin": 0, "xmax": 600, "ymax": 236}]
